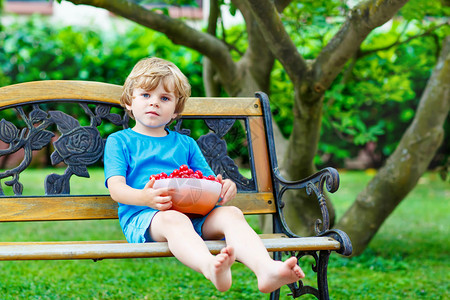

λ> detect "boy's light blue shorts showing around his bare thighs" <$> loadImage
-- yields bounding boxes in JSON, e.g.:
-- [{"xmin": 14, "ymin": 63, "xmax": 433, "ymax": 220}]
[{"xmin": 123, "ymin": 206, "xmax": 218, "ymax": 243}]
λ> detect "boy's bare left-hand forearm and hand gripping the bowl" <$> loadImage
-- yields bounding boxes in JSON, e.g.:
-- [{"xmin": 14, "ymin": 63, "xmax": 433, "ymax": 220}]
[{"xmin": 108, "ymin": 176, "xmax": 172, "ymax": 210}]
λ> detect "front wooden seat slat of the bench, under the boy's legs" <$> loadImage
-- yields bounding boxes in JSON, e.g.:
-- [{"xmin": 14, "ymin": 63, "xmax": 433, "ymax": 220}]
[{"xmin": 0, "ymin": 234, "xmax": 340, "ymax": 260}]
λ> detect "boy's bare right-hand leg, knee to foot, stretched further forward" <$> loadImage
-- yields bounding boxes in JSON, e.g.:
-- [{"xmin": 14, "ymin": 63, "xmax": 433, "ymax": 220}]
[{"xmin": 202, "ymin": 206, "xmax": 305, "ymax": 293}]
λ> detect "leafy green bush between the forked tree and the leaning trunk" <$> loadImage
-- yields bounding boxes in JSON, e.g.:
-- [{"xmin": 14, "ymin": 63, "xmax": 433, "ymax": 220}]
[{"xmin": 319, "ymin": 22, "xmax": 448, "ymax": 166}]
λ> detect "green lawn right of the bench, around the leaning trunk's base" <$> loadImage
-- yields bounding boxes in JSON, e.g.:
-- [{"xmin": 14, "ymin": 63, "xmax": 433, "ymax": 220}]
[{"xmin": 329, "ymin": 172, "xmax": 450, "ymax": 299}]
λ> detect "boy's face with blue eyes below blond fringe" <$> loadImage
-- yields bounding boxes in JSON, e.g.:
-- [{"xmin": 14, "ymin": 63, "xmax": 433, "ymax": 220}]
[{"xmin": 126, "ymin": 84, "xmax": 177, "ymax": 136}]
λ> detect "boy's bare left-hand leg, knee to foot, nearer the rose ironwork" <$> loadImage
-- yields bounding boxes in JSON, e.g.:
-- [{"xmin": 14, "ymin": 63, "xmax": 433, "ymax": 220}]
[{"xmin": 149, "ymin": 210, "xmax": 235, "ymax": 291}]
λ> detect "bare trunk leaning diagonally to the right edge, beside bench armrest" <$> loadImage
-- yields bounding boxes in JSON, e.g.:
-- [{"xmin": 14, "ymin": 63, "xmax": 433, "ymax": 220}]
[{"xmin": 336, "ymin": 37, "xmax": 450, "ymax": 255}]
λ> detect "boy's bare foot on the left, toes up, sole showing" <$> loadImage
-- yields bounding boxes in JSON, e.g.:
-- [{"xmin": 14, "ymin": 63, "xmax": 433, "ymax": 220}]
[{"xmin": 205, "ymin": 246, "xmax": 236, "ymax": 292}]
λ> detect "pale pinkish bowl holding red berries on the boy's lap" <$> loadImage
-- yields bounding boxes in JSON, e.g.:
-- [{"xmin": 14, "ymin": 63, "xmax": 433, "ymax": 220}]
[{"xmin": 153, "ymin": 178, "xmax": 222, "ymax": 216}]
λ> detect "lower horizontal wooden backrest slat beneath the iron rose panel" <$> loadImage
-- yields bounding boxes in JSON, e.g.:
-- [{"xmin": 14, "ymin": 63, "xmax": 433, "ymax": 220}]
[{"xmin": 0, "ymin": 193, "xmax": 275, "ymax": 222}]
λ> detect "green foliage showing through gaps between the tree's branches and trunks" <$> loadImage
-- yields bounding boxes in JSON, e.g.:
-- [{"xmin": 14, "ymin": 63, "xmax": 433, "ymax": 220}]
[{"xmin": 264, "ymin": 0, "xmax": 449, "ymax": 167}]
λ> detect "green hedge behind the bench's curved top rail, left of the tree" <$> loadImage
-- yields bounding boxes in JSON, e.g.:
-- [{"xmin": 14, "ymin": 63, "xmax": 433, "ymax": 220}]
[{"xmin": 0, "ymin": 16, "xmax": 204, "ymax": 137}]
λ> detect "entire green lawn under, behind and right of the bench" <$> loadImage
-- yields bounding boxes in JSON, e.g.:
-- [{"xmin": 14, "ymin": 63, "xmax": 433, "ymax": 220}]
[{"xmin": 0, "ymin": 170, "xmax": 450, "ymax": 299}]
